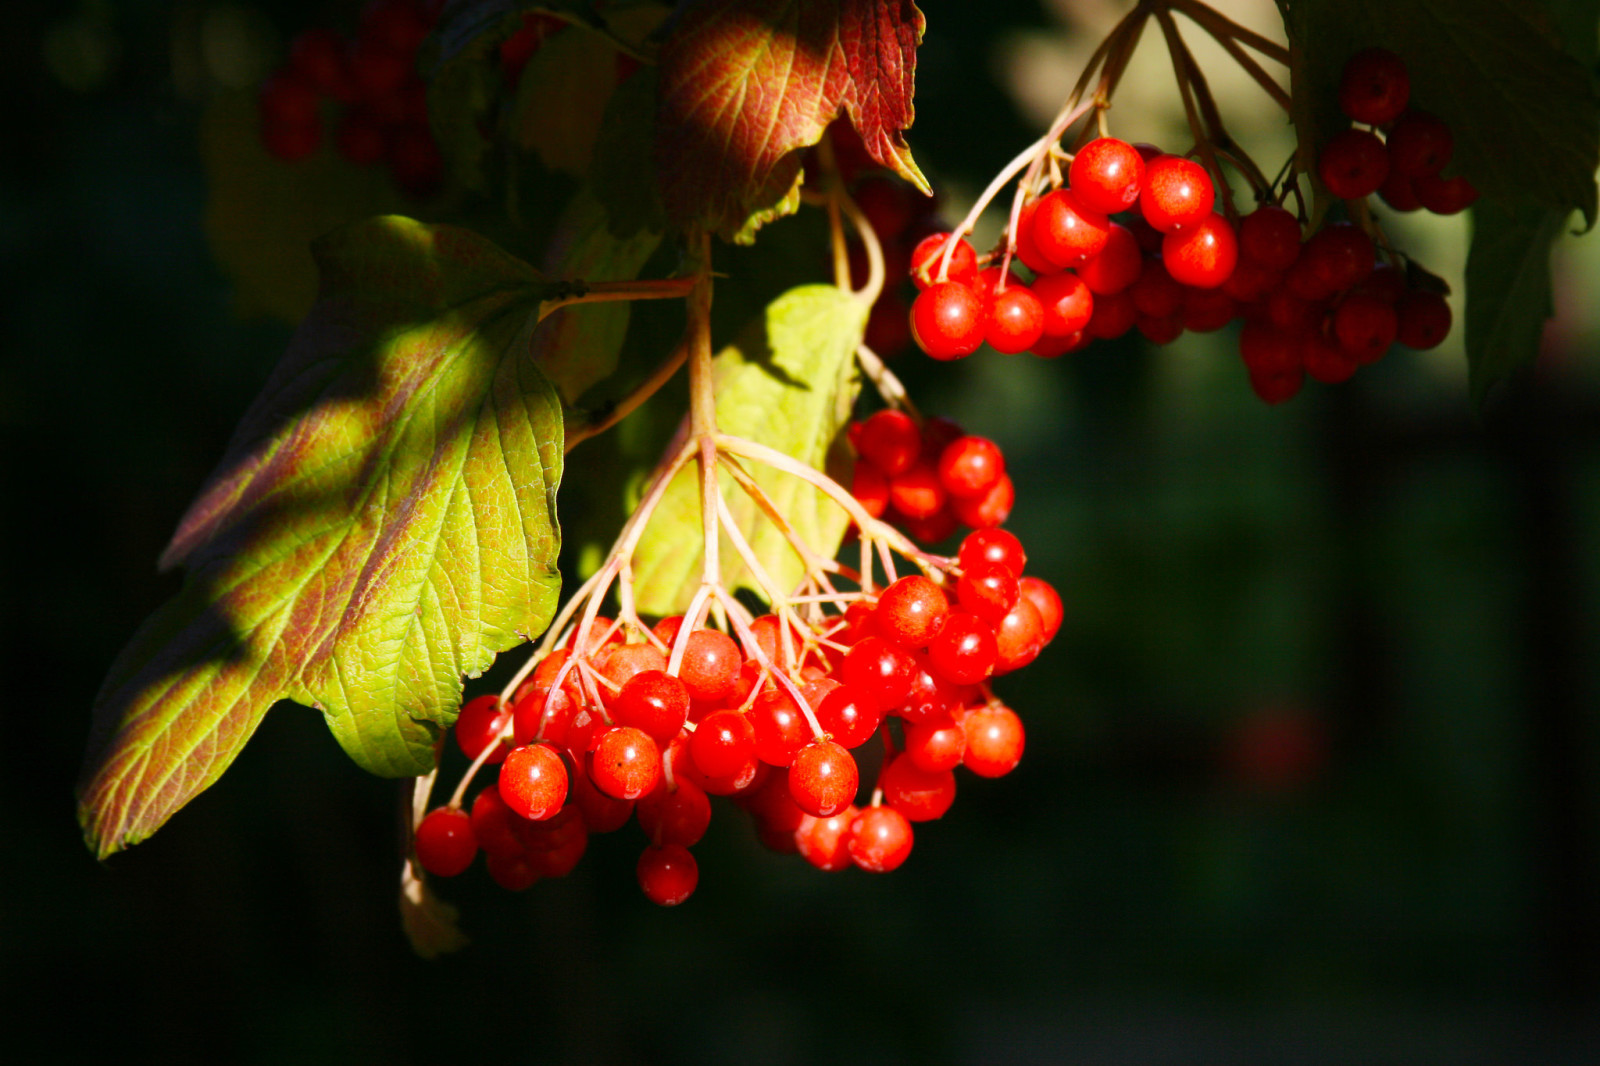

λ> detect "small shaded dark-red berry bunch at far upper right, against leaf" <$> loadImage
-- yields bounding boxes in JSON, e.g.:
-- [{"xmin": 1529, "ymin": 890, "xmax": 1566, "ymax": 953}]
[{"xmin": 1317, "ymin": 48, "xmax": 1478, "ymax": 214}]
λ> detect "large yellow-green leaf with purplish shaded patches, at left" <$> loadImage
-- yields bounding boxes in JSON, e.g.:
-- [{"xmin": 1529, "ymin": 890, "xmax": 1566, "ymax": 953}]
[{"xmin": 78, "ymin": 218, "xmax": 562, "ymax": 856}]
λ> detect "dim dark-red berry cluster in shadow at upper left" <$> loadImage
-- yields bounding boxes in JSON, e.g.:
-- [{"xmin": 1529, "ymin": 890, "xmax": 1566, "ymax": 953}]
[{"xmin": 259, "ymin": 0, "xmax": 443, "ymax": 197}]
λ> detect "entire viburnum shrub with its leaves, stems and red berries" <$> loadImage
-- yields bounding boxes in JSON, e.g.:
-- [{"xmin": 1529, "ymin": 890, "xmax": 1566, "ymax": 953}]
[{"xmin": 80, "ymin": 0, "xmax": 1600, "ymax": 954}]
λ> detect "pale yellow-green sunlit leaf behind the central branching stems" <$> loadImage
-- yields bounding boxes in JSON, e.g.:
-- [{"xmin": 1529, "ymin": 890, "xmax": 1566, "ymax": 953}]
[{"xmin": 634, "ymin": 285, "xmax": 867, "ymax": 616}]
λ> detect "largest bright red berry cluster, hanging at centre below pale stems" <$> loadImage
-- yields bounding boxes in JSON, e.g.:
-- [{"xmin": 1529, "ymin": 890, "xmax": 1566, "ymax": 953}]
[{"xmin": 416, "ymin": 530, "xmax": 1062, "ymax": 904}]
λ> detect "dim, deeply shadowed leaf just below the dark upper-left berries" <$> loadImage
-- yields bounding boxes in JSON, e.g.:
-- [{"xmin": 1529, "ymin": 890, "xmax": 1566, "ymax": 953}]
[{"xmin": 200, "ymin": 91, "xmax": 414, "ymax": 322}]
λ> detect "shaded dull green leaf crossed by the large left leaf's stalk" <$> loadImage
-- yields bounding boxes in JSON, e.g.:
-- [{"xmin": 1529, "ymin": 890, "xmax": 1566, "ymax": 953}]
[{"xmin": 533, "ymin": 189, "xmax": 661, "ymax": 405}]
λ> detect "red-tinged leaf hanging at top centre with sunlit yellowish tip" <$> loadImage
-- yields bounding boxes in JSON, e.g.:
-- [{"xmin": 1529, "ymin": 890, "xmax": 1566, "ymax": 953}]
[{"xmin": 656, "ymin": 0, "xmax": 928, "ymax": 243}]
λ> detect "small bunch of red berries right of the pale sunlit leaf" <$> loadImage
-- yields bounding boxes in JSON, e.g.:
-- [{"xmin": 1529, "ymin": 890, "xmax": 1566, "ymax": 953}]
[{"xmin": 848, "ymin": 408, "xmax": 1016, "ymax": 544}]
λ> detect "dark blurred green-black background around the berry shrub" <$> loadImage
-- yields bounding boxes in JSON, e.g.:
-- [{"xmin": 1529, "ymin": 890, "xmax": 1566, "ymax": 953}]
[{"xmin": 9, "ymin": 0, "xmax": 1600, "ymax": 1064}]
